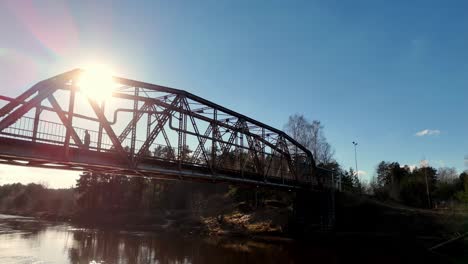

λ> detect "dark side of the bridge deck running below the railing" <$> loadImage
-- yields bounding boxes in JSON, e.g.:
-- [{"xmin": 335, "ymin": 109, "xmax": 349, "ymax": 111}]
[{"xmin": 0, "ymin": 138, "xmax": 308, "ymax": 189}]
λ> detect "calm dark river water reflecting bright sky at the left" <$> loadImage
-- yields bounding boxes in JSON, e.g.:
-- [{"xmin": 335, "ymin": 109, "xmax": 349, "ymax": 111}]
[{"xmin": 0, "ymin": 215, "xmax": 460, "ymax": 264}]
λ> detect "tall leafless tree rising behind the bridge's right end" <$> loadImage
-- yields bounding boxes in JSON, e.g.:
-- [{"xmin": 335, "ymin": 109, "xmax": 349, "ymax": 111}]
[{"xmin": 284, "ymin": 114, "xmax": 335, "ymax": 164}]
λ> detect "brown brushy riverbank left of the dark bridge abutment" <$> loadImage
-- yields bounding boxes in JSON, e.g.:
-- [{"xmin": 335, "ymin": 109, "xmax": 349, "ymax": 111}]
[{"xmin": 0, "ymin": 198, "xmax": 291, "ymax": 240}]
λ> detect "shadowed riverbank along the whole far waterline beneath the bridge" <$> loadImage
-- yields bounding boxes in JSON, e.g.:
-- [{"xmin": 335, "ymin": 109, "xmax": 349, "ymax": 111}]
[{"xmin": 2, "ymin": 193, "xmax": 468, "ymax": 244}]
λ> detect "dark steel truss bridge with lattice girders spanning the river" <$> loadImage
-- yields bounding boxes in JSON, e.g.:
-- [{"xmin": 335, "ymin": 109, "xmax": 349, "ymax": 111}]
[{"xmin": 0, "ymin": 69, "xmax": 321, "ymax": 188}]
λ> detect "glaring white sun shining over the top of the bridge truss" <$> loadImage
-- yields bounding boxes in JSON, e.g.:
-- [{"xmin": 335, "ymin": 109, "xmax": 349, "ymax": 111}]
[{"xmin": 77, "ymin": 64, "xmax": 116, "ymax": 102}]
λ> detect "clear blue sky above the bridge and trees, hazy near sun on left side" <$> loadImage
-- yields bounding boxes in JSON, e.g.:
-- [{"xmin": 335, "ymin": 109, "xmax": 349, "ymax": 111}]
[{"xmin": 0, "ymin": 0, "xmax": 468, "ymax": 187}]
